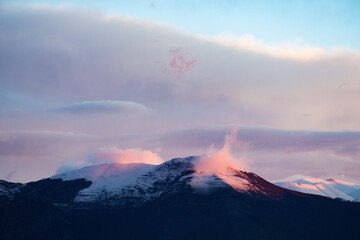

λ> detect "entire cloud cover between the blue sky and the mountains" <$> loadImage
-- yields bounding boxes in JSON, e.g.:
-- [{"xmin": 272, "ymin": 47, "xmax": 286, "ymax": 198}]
[{"xmin": 0, "ymin": 6, "xmax": 360, "ymax": 181}]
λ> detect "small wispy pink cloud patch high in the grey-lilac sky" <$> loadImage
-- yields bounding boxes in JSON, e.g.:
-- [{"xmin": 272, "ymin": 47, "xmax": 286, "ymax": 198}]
[{"xmin": 169, "ymin": 48, "xmax": 196, "ymax": 78}]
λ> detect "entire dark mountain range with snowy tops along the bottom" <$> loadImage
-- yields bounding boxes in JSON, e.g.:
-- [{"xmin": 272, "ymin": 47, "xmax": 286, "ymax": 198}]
[{"xmin": 0, "ymin": 157, "xmax": 360, "ymax": 239}]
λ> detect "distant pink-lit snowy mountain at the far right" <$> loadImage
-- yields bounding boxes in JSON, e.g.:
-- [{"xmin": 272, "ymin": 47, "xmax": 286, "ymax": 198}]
[{"xmin": 275, "ymin": 177, "xmax": 360, "ymax": 201}]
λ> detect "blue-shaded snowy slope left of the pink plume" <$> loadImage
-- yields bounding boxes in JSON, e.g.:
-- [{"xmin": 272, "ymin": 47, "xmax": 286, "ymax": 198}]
[{"xmin": 52, "ymin": 157, "xmax": 195, "ymax": 205}]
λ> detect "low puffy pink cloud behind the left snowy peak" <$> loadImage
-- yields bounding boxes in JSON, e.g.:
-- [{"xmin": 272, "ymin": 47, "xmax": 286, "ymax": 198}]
[{"xmin": 88, "ymin": 147, "xmax": 163, "ymax": 165}]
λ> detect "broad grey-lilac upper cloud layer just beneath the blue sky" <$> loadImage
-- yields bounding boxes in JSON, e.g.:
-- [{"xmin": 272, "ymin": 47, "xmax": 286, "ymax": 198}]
[{"xmin": 0, "ymin": 7, "xmax": 360, "ymax": 130}]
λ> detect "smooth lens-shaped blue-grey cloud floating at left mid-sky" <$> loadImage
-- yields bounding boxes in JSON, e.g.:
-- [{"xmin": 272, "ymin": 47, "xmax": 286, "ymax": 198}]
[{"xmin": 52, "ymin": 100, "xmax": 152, "ymax": 114}]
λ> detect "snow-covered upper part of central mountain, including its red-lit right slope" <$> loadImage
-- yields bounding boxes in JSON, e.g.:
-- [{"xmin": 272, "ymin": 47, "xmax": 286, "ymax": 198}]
[{"xmin": 52, "ymin": 156, "xmax": 316, "ymax": 206}]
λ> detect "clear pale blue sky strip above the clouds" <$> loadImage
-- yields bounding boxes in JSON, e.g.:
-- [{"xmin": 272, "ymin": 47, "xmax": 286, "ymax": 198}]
[{"xmin": 2, "ymin": 0, "xmax": 360, "ymax": 51}]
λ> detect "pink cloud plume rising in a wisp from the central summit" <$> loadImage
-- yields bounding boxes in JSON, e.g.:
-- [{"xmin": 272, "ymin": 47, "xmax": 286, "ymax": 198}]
[{"xmin": 195, "ymin": 127, "xmax": 247, "ymax": 173}]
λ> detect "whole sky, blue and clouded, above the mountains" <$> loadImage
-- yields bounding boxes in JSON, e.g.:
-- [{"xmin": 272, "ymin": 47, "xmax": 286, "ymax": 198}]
[{"xmin": 0, "ymin": 0, "xmax": 360, "ymax": 182}]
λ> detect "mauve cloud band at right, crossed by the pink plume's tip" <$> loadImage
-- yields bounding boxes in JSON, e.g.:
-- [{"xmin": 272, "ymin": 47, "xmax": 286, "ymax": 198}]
[{"xmin": 161, "ymin": 127, "xmax": 360, "ymax": 158}]
